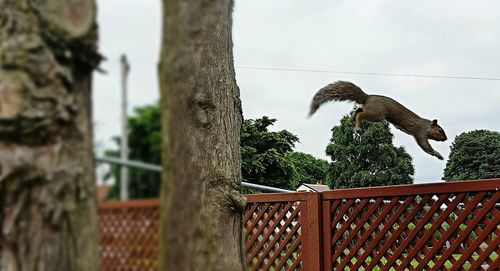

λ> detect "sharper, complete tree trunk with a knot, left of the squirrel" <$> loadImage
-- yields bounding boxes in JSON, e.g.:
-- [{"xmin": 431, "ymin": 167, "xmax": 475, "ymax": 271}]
[{"xmin": 159, "ymin": 0, "xmax": 245, "ymax": 271}]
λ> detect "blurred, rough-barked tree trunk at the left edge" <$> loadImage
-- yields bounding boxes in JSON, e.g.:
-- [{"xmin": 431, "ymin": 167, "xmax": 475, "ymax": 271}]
[{"xmin": 0, "ymin": 0, "xmax": 100, "ymax": 271}]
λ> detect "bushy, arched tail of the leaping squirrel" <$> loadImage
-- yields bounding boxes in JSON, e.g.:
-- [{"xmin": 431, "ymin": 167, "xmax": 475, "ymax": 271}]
[{"xmin": 309, "ymin": 81, "xmax": 368, "ymax": 116}]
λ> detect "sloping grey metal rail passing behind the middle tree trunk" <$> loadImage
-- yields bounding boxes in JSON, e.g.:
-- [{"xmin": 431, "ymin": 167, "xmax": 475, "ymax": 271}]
[{"xmin": 95, "ymin": 157, "xmax": 295, "ymax": 193}]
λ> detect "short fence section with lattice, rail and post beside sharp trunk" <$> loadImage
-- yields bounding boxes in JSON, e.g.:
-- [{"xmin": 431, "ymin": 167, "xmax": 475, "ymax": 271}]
[{"xmin": 244, "ymin": 192, "xmax": 321, "ymax": 270}]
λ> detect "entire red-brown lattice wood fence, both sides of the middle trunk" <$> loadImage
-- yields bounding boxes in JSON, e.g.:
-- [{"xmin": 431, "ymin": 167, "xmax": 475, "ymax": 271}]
[{"xmin": 99, "ymin": 179, "xmax": 500, "ymax": 271}]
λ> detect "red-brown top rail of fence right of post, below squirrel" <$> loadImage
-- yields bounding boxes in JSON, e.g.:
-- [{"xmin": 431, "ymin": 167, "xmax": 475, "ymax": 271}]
[{"xmin": 322, "ymin": 179, "xmax": 500, "ymax": 200}]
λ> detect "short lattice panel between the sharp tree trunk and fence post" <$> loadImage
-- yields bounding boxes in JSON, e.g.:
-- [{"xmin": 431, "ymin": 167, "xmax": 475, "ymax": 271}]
[{"xmin": 244, "ymin": 201, "xmax": 305, "ymax": 270}]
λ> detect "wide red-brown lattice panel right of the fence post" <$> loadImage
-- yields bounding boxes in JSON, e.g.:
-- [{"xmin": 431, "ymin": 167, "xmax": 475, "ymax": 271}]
[{"xmin": 325, "ymin": 191, "xmax": 500, "ymax": 270}]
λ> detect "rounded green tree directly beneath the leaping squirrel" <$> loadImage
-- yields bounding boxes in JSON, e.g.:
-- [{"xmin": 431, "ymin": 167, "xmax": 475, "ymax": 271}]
[{"xmin": 326, "ymin": 116, "xmax": 415, "ymax": 188}]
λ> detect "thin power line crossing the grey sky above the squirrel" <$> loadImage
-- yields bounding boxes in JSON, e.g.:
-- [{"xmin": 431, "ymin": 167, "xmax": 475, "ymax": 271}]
[{"xmin": 236, "ymin": 66, "xmax": 500, "ymax": 81}]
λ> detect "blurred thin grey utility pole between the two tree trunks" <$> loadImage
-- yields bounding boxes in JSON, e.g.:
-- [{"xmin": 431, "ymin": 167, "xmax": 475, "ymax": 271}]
[{"xmin": 120, "ymin": 54, "xmax": 130, "ymax": 200}]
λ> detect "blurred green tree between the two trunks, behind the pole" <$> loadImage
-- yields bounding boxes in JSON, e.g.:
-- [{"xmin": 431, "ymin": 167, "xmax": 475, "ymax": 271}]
[{"xmin": 105, "ymin": 103, "xmax": 161, "ymax": 199}]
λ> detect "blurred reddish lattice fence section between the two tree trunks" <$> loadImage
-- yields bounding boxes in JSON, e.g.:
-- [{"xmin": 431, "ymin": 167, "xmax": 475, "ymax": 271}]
[{"xmin": 99, "ymin": 201, "xmax": 160, "ymax": 271}]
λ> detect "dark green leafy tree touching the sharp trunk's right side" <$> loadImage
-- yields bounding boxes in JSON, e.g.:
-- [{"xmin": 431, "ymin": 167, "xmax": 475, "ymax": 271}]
[{"xmin": 241, "ymin": 116, "xmax": 328, "ymax": 190}]
